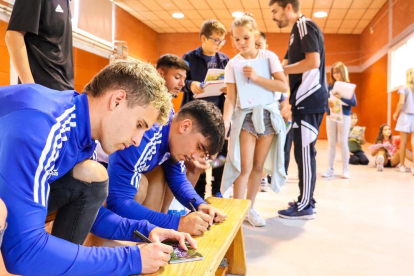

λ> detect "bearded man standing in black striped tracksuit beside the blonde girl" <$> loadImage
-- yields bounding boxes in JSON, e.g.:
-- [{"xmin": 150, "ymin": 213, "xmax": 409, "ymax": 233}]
[{"xmin": 269, "ymin": 0, "xmax": 328, "ymax": 219}]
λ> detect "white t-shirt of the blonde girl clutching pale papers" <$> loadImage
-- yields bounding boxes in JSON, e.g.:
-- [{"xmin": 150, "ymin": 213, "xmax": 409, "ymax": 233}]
[{"xmin": 224, "ymin": 50, "xmax": 283, "ymax": 105}]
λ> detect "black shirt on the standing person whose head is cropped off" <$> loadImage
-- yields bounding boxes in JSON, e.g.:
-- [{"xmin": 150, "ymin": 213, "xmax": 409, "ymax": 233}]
[{"xmin": 7, "ymin": 0, "xmax": 74, "ymax": 90}]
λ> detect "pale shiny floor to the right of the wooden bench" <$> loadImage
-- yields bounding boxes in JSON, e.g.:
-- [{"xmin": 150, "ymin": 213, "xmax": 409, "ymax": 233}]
[{"xmin": 236, "ymin": 140, "xmax": 414, "ymax": 276}]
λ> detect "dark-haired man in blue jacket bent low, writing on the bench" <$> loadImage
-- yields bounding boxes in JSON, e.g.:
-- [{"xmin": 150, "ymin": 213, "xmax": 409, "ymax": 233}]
[{"xmin": 94, "ymin": 101, "xmax": 226, "ymax": 238}]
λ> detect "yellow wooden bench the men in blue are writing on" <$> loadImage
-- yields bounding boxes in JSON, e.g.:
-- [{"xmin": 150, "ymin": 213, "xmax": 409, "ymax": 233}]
[{"xmin": 139, "ymin": 197, "xmax": 250, "ymax": 276}]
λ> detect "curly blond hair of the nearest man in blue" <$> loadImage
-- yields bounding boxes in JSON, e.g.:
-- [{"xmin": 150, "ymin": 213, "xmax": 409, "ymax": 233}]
[{"xmin": 84, "ymin": 61, "xmax": 172, "ymax": 124}]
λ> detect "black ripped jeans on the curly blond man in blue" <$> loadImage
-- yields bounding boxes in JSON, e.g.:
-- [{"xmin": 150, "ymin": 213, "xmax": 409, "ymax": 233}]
[{"xmin": 47, "ymin": 170, "xmax": 108, "ymax": 244}]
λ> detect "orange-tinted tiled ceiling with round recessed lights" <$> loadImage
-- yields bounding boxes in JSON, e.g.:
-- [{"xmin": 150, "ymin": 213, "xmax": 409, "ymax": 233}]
[{"xmin": 115, "ymin": 0, "xmax": 387, "ymax": 34}]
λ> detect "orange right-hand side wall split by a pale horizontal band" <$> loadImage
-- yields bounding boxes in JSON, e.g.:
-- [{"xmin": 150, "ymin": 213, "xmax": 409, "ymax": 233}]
[{"xmin": 357, "ymin": 0, "xmax": 414, "ymax": 143}]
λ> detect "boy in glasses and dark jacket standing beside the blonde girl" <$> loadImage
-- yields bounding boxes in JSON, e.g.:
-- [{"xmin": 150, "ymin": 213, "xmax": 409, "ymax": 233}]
[{"xmin": 181, "ymin": 19, "xmax": 229, "ymax": 198}]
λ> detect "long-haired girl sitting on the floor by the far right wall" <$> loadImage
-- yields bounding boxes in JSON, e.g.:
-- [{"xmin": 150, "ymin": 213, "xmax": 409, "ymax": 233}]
[{"xmin": 369, "ymin": 124, "xmax": 413, "ymax": 171}]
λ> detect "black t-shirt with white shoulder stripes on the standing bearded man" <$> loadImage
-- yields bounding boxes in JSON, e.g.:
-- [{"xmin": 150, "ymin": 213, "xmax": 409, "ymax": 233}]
[{"xmin": 285, "ymin": 16, "xmax": 328, "ymax": 115}]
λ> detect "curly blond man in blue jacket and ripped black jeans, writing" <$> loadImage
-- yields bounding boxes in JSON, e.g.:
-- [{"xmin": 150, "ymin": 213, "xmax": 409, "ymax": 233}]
[{"xmin": 0, "ymin": 62, "xmax": 193, "ymax": 275}]
